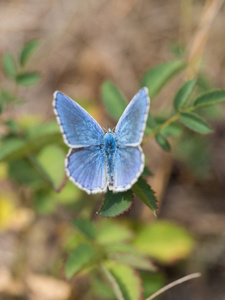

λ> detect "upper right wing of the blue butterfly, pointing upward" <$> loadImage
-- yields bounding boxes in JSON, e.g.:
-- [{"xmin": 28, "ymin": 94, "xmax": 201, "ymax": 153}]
[{"xmin": 115, "ymin": 88, "xmax": 150, "ymax": 146}]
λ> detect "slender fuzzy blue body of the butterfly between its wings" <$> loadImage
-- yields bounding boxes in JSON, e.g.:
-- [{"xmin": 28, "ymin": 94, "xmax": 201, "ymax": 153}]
[{"xmin": 104, "ymin": 131, "xmax": 116, "ymax": 184}]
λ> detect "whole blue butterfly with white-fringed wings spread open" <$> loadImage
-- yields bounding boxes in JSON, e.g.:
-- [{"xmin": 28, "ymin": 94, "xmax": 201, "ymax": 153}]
[{"xmin": 53, "ymin": 88, "xmax": 150, "ymax": 194}]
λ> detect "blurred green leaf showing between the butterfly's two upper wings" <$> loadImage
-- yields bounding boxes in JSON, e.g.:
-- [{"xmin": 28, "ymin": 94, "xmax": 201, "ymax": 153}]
[{"xmin": 101, "ymin": 80, "xmax": 127, "ymax": 120}]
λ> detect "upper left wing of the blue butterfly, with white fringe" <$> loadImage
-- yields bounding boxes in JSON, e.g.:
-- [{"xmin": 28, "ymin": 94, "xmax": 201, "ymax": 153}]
[{"xmin": 53, "ymin": 92, "xmax": 104, "ymax": 148}]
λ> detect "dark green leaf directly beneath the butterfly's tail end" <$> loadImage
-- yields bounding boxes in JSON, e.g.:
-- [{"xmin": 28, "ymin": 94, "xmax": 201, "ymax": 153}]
[{"xmin": 98, "ymin": 190, "xmax": 133, "ymax": 217}]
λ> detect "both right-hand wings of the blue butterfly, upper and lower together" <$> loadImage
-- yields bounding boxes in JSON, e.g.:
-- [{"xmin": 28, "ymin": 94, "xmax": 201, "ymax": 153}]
[{"xmin": 111, "ymin": 88, "xmax": 150, "ymax": 192}]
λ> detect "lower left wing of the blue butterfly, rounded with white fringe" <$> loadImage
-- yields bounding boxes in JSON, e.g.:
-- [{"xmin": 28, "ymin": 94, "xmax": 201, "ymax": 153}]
[{"xmin": 65, "ymin": 146, "xmax": 107, "ymax": 194}]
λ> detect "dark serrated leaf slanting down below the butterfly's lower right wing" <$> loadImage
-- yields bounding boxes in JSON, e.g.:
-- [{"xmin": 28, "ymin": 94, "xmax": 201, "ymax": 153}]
[{"xmin": 132, "ymin": 177, "xmax": 157, "ymax": 216}]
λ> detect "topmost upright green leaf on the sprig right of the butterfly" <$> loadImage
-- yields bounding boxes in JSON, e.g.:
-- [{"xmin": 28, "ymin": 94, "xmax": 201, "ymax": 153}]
[{"xmin": 173, "ymin": 79, "xmax": 196, "ymax": 111}]
